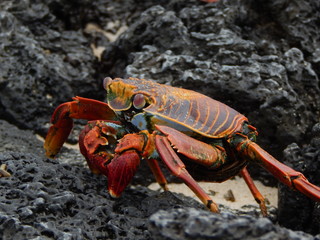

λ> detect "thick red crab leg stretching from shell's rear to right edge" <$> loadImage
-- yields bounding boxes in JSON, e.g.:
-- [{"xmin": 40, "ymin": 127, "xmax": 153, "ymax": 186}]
[{"xmin": 237, "ymin": 140, "xmax": 320, "ymax": 202}]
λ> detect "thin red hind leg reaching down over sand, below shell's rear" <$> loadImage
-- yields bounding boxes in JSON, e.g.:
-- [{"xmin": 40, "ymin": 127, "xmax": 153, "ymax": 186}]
[{"xmin": 240, "ymin": 167, "xmax": 268, "ymax": 217}]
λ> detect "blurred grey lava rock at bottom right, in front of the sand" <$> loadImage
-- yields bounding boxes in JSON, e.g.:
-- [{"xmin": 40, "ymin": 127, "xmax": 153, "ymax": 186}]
[{"xmin": 149, "ymin": 208, "xmax": 314, "ymax": 240}]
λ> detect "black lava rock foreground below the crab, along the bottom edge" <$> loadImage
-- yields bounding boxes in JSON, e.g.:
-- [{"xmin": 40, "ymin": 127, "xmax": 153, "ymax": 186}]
[{"xmin": 0, "ymin": 149, "xmax": 314, "ymax": 240}]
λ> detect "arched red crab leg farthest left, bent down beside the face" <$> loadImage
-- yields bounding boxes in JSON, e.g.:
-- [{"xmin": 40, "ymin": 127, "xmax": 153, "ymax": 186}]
[{"xmin": 44, "ymin": 97, "xmax": 116, "ymax": 157}]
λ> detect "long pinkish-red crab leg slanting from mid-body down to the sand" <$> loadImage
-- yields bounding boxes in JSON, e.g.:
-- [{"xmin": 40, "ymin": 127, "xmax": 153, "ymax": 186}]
[{"xmin": 155, "ymin": 135, "xmax": 219, "ymax": 212}]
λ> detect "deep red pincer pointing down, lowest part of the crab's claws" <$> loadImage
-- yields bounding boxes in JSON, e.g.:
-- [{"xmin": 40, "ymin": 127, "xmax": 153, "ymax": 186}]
[{"xmin": 106, "ymin": 150, "xmax": 140, "ymax": 198}]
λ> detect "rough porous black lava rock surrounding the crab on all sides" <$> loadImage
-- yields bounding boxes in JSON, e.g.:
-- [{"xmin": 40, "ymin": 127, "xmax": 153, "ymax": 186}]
[{"xmin": 0, "ymin": 0, "xmax": 320, "ymax": 239}]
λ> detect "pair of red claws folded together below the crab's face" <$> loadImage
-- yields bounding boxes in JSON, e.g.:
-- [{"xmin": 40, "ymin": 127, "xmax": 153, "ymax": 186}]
[{"xmin": 79, "ymin": 120, "xmax": 145, "ymax": 197}]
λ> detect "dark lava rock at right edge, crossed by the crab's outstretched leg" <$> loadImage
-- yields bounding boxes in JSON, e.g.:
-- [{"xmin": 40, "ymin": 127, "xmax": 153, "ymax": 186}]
[{"xmin": 278, "ymin": 123, "xmax": 320, "ymax": 233}]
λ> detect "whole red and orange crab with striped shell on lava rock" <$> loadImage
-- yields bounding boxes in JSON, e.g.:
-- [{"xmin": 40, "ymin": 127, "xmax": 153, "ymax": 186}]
[{"xmin": 44, "ymin": 78, "xmax": 320, "ymax": 215}]
